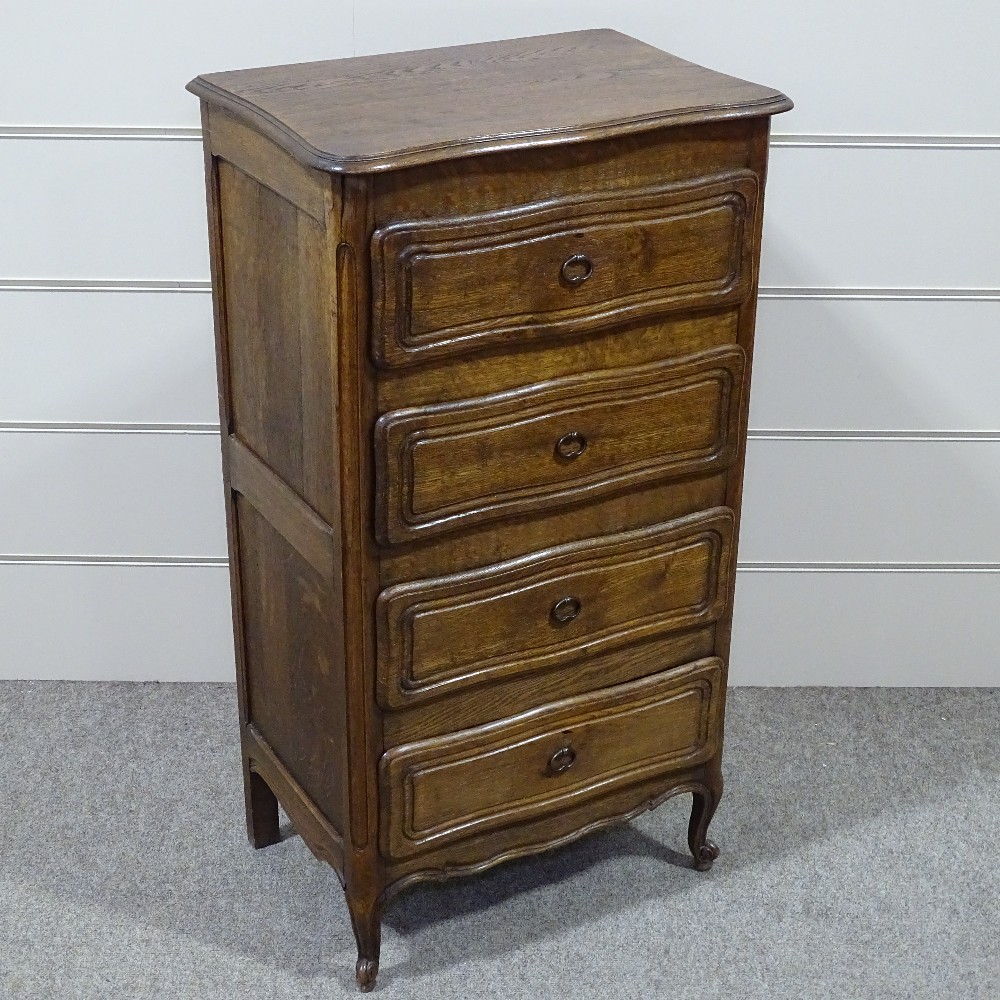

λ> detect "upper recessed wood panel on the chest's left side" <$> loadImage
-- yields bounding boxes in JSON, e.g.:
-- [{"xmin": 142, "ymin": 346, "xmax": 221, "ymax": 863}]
[{"xmin": 218, "ymin": 154, "xmax": 339, "ymax": 523}]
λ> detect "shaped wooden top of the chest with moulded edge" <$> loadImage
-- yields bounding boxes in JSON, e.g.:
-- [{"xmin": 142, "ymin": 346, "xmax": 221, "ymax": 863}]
[{"xmin": 188, "ymin": 29, "xmax": 792, "ymax": 173}]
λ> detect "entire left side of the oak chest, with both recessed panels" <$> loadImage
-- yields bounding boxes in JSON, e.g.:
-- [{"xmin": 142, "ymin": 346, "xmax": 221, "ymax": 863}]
[{"xmin": 203, "ymin": 103, "xmax": 348, "ymax": 873}]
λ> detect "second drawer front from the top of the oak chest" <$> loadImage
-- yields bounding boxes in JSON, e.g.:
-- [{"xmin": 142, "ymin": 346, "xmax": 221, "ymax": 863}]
[{"xmin": 375, "ymin": 345, "xmax": 746, "ymax": 544}]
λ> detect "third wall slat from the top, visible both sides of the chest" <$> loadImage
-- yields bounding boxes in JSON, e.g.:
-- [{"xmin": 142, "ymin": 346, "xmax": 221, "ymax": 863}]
[{"xmin": 0, "ymin": 290, "xmax": 1000, "ymax": 433}]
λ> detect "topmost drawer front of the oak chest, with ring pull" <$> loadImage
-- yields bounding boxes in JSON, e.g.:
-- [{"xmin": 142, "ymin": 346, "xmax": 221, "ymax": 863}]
[{"xmin": 372, "ymin": 170, "xmax": 758, "ymax": 368}]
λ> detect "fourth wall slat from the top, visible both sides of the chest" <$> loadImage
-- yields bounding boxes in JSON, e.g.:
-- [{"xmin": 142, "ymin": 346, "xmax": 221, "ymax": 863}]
[{"xmin": 7, "ymin": 432, "xmax": 1000, "ymax": 563}]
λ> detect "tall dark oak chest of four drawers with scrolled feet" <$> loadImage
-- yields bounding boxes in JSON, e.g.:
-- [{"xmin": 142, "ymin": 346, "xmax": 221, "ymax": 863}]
[{"xmin": 189, "ymin": 31, "xmax": 791, "ymax": 989}]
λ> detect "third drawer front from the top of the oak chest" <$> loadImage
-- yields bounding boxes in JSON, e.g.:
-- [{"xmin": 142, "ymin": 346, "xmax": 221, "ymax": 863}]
[{"xmin": 376, "ymin": 507, "xmax": 733, "ymax": 708}]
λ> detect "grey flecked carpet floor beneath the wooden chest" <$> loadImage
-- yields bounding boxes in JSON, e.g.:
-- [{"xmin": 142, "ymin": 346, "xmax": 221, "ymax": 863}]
[{"xmin": 0, "ymin": 682, "xmax": 1000, "ymax": 1000}]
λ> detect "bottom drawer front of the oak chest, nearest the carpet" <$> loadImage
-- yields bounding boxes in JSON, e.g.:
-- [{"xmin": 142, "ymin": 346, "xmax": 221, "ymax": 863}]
[{"xmin": 380, "ymin": 658, "xmax": 723, "ymax": 859}]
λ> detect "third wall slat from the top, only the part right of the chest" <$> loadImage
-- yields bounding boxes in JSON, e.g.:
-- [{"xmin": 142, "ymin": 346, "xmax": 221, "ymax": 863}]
[{"xmin": 750, "ymin": 299, "xmax": 1000, "ymax": 431}]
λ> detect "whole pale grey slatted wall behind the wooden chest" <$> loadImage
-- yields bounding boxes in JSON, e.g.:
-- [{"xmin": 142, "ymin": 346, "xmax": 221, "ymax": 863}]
[{"xmin": 0, "ymin": 0, "xmax": 1000, "ymax": 685}]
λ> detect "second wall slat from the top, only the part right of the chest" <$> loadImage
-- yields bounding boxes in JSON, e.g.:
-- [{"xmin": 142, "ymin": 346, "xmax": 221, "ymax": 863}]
[{"xmin": 761, "ymin": 148, "xmax": 1000, "ymax": 288}]
